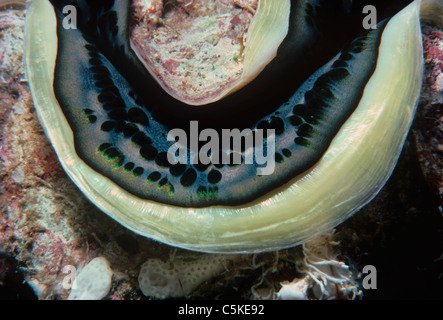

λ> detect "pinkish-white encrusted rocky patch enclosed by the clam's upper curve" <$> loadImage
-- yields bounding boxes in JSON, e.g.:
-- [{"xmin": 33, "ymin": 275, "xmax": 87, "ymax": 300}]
[{"xmin": 132, "ymin": 0, "xmax": 253, "ymax": 100}]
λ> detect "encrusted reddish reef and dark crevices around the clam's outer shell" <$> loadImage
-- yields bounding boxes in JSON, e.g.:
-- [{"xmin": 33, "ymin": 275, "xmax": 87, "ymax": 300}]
[{"xmin": 0, "ymin": 1, "xmax": 443, "ymax": 299}]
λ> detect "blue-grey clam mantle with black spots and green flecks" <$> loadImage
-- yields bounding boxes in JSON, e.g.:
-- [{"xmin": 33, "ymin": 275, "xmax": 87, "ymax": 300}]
[{"xmin": 48, "ymin": 0, "xmax": 398, "ymax": 207}]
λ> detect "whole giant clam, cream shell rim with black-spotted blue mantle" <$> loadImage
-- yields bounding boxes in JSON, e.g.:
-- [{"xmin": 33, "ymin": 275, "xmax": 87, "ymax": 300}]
[{"xmin": 26, "ymin": 0, "xmax": 423, "ymax": 252}]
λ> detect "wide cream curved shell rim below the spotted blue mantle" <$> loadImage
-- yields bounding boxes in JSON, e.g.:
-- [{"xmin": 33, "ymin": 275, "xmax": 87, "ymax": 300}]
[{"xmin": 25, "ymin": 0, "xmax": 423, "ymax": 252}]
